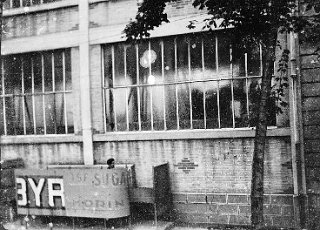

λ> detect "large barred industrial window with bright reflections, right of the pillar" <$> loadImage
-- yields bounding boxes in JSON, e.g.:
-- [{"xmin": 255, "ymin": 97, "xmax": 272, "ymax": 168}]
[{"xmin": 103, "ymin": 34, "xmax": 284, "ymax": 131}]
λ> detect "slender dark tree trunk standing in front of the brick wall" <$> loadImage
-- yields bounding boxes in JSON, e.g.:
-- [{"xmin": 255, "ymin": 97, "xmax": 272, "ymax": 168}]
[{"xmin": 251, "ymin": 41, "xmax": 275, "ymax": 229}]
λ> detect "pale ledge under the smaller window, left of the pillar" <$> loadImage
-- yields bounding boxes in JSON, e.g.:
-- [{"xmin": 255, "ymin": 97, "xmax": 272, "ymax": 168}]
[{"xmin": 0, "ymin": 134, "xmax": 82, "ymax": 145}]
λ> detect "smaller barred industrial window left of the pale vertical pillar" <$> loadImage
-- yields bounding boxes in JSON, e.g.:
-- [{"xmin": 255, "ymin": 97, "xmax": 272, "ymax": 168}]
[{"xmin": 0, "ymin": 50, "xmax": 73, "ymax": 135}]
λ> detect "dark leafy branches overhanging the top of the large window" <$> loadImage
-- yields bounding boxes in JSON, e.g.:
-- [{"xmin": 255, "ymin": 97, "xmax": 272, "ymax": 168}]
[{"xmin": 124, "ymin": 0, "xmax": 302, "ymax": 47}]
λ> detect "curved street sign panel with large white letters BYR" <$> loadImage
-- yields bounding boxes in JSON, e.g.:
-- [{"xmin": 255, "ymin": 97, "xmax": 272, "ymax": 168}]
[{"xmin": 15, "ymin": 166, "xmax": 130, "ymax": 219}]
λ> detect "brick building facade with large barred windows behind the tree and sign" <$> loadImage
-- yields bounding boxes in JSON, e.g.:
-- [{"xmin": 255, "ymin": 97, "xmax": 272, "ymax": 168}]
[{"xmin": 0, "ymin": 0, "xmax": 320, "ymax": 227}]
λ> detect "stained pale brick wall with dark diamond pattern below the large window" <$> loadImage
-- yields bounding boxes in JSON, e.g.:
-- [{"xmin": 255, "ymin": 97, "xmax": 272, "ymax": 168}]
[{"xmin": 94, "ymin": 138, "xmax": 295, "ymax": 227}]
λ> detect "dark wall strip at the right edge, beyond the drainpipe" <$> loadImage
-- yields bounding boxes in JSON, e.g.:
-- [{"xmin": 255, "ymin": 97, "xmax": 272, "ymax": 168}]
[{"xmin": 300, "ymin": 39, "xmax": 320, "ymax": 229}]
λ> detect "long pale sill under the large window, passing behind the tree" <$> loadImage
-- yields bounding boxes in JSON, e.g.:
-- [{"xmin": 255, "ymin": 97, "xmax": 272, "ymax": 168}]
[{"xmin": 93, "ymin": 128, "xmax": 290, "ymax": 142}]
